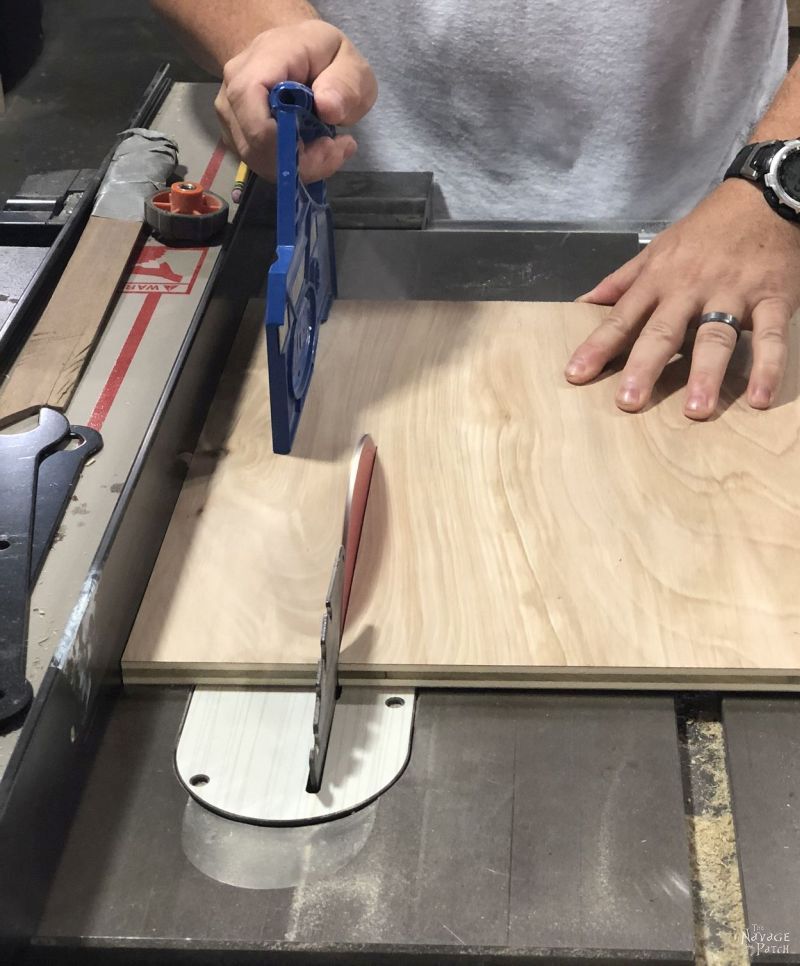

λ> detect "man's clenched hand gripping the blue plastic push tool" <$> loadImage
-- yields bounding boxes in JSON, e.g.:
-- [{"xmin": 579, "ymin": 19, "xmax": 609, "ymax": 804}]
[{"xmin": 214, "ymin": 20, "xmax": 378, "ymax": 181}]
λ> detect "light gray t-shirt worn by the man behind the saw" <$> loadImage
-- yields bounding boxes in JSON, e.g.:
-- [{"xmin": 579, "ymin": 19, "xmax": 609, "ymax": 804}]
[{"xmin": 317, "ymin": 0, "xmax": 788, "ymax": 220}]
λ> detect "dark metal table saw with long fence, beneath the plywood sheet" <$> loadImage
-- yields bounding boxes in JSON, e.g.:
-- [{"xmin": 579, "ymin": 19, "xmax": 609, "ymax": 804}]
[{"xmin": 0, "ymin": 70, "xmax": 800, "ymax": 964}]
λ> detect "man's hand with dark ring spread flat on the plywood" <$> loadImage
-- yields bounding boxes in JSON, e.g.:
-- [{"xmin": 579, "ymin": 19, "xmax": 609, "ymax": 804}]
[{"xmin": 566, "ymin": 181, "xmax": 800, "ymax": 419}]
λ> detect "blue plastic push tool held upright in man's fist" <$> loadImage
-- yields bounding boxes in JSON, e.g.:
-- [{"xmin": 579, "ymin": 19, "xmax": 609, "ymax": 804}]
[{"xmin": 264, "ymin": 81, "xmax": 336, "ymax": 453}]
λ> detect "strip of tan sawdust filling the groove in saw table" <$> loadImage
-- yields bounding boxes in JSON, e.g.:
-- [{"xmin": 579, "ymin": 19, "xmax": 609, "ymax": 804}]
[{"xmin": 686, "ymin": 720, "xmax": 750, "ymax": 966}]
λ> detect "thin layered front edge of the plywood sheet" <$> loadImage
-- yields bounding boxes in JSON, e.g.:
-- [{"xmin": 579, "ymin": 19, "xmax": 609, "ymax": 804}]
[{"xmin": 122, "ymin": 662, "xmax": 800, "ymax": 691}]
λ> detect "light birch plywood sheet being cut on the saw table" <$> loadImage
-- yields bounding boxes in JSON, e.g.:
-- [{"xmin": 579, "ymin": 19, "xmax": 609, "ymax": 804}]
[{"xmin": 123, "ymin": 302, "xmax": 800, "ymax": 687}]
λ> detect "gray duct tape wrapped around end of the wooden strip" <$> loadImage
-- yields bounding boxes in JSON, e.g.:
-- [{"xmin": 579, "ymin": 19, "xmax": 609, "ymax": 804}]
[{"xmin": 92, "ymin": 127, "xmax": 178, "ymax": 221}]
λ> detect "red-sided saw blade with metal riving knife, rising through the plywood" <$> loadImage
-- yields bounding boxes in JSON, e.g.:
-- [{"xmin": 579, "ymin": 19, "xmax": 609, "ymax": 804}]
[{"xmin": 306, "ymin": 436, "xmax": 378, "ymax": 792}]
